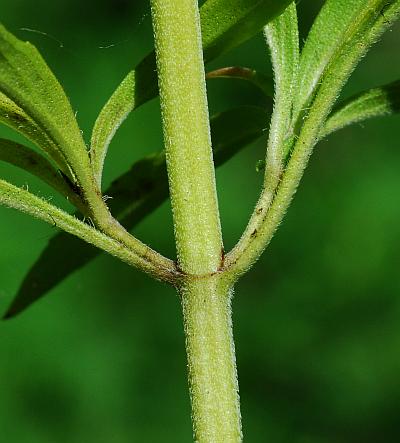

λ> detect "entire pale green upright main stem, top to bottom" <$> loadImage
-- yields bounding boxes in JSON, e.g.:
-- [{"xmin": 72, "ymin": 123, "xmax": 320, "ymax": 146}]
[{"xmin": 151, "ymin": 0, "xmax": 241, "ymax": 443}]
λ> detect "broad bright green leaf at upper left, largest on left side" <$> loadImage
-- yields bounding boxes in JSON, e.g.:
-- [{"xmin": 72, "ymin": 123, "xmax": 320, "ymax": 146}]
[{"xmin": 0, "ymin": 25, "xmax": 89, "ymax": 186}]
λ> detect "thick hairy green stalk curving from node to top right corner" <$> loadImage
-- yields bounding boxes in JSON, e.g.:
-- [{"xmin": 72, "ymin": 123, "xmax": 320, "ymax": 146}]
[{"xmin": 225, "ymin": 0, "xmax": 400, "ymax": 279}]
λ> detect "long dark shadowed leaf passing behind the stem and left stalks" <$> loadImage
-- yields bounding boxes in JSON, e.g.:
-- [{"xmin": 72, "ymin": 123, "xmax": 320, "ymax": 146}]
[{"xmin": 7, "ymin": 106, "xmax": 269, "ymax": 317}]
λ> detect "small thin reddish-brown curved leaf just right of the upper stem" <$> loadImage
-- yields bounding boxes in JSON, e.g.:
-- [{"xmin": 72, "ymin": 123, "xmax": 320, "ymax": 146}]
[{"xmin": 206, "ymin": 66, "xmax": 274, "ymax": 97}]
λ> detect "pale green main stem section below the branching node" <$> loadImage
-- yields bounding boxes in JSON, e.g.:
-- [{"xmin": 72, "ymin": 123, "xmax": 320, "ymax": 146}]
[{"xmin": 180, "ymin": 276, "xmax": 242, "ymax": 443}]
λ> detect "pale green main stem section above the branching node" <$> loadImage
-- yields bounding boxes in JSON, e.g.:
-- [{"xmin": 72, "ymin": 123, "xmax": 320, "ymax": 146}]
[{"xmin": 151, "ymin": 0, "xmax": 222, "ymax": 275}]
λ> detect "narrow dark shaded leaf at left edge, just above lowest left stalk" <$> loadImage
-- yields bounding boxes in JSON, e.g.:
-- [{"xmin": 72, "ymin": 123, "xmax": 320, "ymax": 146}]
[{"xmin": 0, "ymin": 138, "xmax": 79, "ymax": 207}]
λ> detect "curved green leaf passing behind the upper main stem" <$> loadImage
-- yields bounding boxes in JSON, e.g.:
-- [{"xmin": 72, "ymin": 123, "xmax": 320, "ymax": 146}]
[{"xmin": 90, "ymin": 0, "xmax": 290, "ymax": 187}]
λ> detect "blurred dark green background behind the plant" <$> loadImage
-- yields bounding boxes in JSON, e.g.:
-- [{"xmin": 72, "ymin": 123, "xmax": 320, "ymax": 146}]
[{"xmin": 0, "ymin": 0, "xmax": 400, "ymax": 443}]
